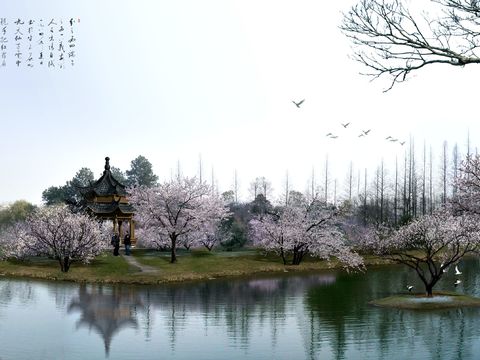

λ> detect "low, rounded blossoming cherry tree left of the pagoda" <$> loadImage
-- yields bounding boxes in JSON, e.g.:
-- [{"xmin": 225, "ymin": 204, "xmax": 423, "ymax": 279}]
[{"xmin": 9, "ymin": 206, "xmax": 109, "ymax": 272}]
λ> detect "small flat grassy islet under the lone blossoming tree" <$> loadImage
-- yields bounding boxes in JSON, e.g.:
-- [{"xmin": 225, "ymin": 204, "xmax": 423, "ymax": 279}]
[{"xmin": 369, "ymin": 291, "xmax": 480, "ymax": 310}]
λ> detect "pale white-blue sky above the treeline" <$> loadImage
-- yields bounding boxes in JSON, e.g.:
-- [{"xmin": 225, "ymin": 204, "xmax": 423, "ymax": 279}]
[{"xmin": 0, "ymin": 0, "xmax": 480, "ymax": 204}]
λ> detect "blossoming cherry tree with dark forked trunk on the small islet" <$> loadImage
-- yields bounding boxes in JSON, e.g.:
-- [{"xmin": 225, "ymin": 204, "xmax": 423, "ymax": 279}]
[{"xmin": 370, "ymin": 208, "xmax": 480, "ymax": 297}]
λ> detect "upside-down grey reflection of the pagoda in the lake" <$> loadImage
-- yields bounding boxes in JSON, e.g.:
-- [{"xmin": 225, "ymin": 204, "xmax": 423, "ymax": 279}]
[{"xmin": 68, "ymin": 284, "xmax": 142, "ymax": 356}]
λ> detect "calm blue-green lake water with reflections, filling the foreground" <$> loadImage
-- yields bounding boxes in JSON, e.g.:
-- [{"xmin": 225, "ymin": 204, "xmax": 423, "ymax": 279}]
[{"xmin": 0, "ymin": 259, "xmax": 480, "ymax": 360}]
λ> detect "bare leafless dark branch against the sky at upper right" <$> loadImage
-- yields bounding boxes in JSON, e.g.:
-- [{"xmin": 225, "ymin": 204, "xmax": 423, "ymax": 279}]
[{"xmin": 340, "ymin": 0, "xmax": 480, "ymax": 91}]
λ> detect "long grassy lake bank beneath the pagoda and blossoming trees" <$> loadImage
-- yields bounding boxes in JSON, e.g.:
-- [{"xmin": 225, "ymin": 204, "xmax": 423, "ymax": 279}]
[{"xmin": 0, "ymin": 249, "xmax": 385, "ymax": 284}]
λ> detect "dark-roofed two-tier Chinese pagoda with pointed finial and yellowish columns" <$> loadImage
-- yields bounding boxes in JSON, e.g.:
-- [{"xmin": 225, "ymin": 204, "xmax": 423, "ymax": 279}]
[{"xmin": 78, "ymin": 156, "xmax": 136, "ymax": 245}]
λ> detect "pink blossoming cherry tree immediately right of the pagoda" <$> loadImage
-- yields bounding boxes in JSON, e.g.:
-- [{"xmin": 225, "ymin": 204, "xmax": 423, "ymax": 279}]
[{"xmin": 130, "ymin": 178, "xmax": 228, "ymax": 263}]
